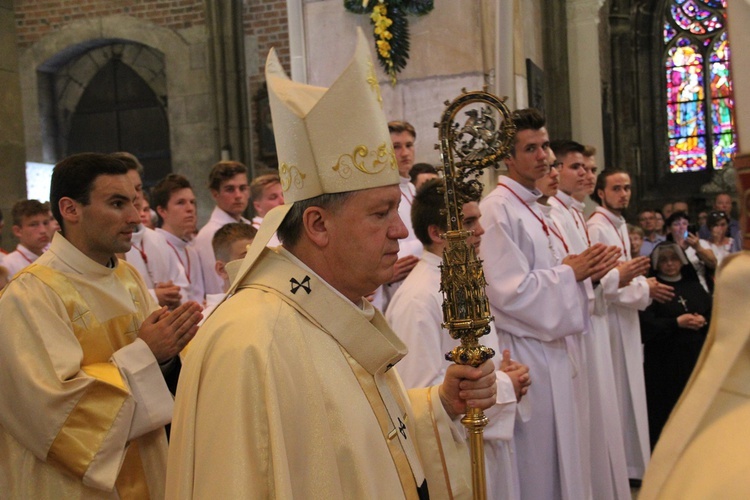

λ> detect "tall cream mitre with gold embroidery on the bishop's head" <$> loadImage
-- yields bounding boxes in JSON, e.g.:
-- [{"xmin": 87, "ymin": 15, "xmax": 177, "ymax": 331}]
[{"xmin": 266, "ymin": 28, "xmax": 399, "ymax": 204}]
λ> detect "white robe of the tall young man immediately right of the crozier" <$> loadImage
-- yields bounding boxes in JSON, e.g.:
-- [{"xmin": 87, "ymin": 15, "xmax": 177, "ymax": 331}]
[{"xmin": 480, "ymin": 177, "xmax": 588, "ymax": 500}]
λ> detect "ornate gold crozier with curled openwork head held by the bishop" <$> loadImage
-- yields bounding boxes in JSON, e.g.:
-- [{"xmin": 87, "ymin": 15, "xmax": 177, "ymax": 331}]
[{"xmin": 435, "ymin": 89, "xmax": 515, "ymax": 500}]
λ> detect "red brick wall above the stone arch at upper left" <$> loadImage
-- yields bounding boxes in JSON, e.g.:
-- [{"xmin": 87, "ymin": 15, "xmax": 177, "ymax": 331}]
[{"xmin": 14, "ymin": 0, "xmax": 207, "ymax": 47}]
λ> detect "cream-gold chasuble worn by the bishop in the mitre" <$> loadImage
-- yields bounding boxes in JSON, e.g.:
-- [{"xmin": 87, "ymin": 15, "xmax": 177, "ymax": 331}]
[{"xmin": 167, "ymin": 247, "xmax": 471, "ymax": 499}]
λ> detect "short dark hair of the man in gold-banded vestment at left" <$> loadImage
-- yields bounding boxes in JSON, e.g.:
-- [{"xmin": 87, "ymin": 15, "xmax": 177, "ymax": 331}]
[{"xmin": 49, "ymin": 153, "xmax": 128, "ymax": 235}]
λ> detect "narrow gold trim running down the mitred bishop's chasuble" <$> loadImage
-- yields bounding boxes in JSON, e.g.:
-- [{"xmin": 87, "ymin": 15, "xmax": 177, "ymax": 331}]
[{"xmin": 245, "ymin": 284, "xmax": 419, "ymax": 500}]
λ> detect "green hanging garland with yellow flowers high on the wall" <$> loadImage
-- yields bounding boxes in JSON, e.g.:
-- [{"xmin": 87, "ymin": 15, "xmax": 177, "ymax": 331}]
[{"xmin": 344, "ymin": 0, "xmax": 434, "ymax": 85}]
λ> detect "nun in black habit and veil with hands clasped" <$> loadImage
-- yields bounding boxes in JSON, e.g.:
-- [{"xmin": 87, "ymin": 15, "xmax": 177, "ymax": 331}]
[{"xmin": 640, "ymin": 241, "xmax": 711, "ymax": 449}]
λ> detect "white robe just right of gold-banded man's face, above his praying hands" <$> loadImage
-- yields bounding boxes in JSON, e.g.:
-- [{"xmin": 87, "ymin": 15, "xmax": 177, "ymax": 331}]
[{"xmin": 125, "ymin": 226, "xmax": 190, "ymax": 303}]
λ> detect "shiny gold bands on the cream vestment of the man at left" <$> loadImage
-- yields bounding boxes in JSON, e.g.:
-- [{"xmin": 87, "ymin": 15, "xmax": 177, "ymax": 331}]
[{"xmin": 22, "ymin": 262, "xmax": 149, "ymax": 499}]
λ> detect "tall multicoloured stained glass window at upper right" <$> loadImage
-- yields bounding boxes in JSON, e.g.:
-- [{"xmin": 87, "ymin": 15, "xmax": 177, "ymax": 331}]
[{"xmin": 663, "ymin": 0, "xmax": 737, "ymax": 173}]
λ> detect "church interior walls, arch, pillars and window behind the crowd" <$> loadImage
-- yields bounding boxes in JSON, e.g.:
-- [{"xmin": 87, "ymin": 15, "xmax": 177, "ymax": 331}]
[{"xmin": 0, "ymin": 0, "xmax": 750, "ymax": 249}]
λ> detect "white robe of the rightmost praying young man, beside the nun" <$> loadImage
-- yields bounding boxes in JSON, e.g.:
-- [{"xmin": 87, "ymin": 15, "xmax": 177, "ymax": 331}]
[{"xmin": 588, "ymin": 207, "xmax": 651, "ymax": 479}]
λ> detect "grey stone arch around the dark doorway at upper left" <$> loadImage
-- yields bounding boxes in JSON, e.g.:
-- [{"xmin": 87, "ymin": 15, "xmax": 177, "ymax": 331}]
[{"xmin": 19, "ymin": 15, "xmax": 219, "ymax": 191}]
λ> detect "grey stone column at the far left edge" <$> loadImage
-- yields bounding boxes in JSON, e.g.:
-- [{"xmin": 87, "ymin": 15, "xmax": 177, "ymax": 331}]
[{"xmin": 0, "ymin": 0, "xmax": 26, "ymax": 250}]
